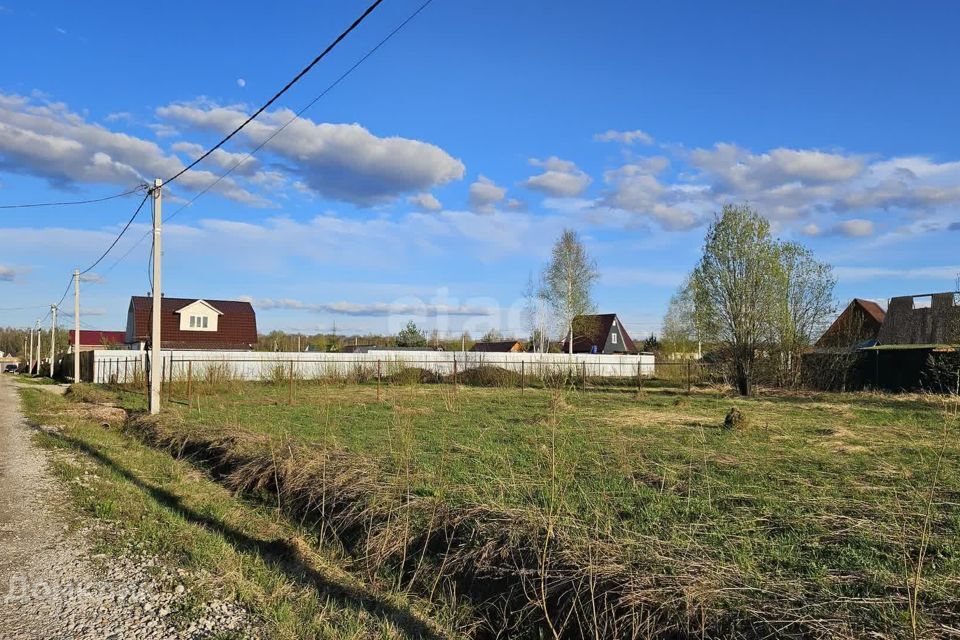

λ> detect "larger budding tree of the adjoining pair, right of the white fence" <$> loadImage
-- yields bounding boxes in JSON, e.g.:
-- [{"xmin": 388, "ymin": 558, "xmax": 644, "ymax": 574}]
[{"xmin": 691, "ymin": 205, "xmax": 781, "ymax": 395}]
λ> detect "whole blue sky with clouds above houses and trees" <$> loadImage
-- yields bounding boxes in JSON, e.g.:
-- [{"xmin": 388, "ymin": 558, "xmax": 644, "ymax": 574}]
[{"xmin": 0, "ymin": 0, "xmax": 960, "ymax": 335}]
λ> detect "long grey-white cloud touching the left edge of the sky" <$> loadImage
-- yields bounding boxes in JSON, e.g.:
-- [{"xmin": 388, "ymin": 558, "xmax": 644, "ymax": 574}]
[{"xmin": 0, "ymin": 93, "xmax": 269, "ymax": 206}]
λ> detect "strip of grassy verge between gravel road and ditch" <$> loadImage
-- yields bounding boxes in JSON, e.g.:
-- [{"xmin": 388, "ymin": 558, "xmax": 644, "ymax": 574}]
[{"xmin": 21, "ymin": 389, "xmax": 457, "ymax": 639}]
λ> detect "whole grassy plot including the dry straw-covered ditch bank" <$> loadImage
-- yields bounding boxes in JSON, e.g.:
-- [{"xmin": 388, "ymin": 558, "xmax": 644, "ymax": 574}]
[{"xmin": 94, "ymin": 383, "xmax": 960, "ymax": 637}]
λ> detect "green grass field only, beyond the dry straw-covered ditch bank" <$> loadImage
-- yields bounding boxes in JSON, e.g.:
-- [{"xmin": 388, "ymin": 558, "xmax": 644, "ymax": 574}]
[{"xmin": 65, "ymin": 383, "xmax": 960, "ymax": 636}]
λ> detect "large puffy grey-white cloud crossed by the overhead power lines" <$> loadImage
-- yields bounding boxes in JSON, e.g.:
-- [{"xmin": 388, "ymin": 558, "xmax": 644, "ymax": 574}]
[{"xmin": 157, "ymin": 101, "xmax": 465, "ymax": 205}]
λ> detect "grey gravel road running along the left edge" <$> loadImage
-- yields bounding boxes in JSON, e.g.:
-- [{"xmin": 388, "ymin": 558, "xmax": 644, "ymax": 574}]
[{"xmin": 0, "ymin": 376, "xmax": 259, "ymax": 640}]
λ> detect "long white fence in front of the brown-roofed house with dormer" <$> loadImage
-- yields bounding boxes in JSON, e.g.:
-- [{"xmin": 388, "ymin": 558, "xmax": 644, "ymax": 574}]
[{"xmin": 89, "ymin": 350, "xmax": 654, "ymax": 383}]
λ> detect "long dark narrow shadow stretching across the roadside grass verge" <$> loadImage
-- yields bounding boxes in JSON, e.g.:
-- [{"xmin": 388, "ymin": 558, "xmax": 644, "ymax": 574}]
[{"xmin": 48, "ymin": 433, "xmax": 445, "ymax": 640}]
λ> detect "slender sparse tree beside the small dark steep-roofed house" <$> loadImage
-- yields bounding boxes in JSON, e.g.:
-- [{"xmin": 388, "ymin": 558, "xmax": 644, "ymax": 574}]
[{"xmin": 543, "ymin": 229, "xmax": 599, "ymax": 354}]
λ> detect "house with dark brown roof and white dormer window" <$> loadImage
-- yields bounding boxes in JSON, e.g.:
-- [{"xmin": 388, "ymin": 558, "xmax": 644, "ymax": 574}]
[{"xmin": 126, "ymin": 296, "xmax": 257, "ymax": 351}]
